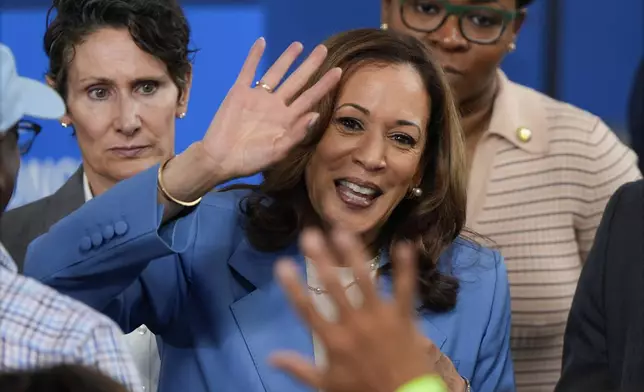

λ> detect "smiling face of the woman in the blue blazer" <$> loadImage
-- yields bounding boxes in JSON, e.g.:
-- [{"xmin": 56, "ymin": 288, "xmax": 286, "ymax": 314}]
[{"xmin": 305, "ymin": 65, "xmax": 430, "ymax": 240}]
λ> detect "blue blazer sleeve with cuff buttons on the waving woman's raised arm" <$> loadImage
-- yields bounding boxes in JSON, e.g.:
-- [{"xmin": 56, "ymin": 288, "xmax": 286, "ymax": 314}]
[{"xmin": 25, "ymin": 166, "xmax": 236, "ymax": 334}]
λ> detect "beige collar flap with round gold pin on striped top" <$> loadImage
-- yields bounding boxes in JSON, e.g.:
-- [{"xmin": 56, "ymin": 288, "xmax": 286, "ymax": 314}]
[{"xmin": 488, "ymin": 70, "xmax": 548, "ymax": 154}]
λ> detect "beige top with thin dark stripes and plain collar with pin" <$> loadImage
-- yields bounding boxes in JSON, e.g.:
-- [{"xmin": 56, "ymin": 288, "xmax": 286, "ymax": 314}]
[{"xmin": 467, "ymin": 72, "xmax": 641, "ymax": 392}]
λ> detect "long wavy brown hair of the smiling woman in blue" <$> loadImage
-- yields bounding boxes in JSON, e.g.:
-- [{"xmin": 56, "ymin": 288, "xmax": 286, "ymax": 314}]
[{"xmin": 234, "ymin": 29, "xmax": 466, "ymax": 311}]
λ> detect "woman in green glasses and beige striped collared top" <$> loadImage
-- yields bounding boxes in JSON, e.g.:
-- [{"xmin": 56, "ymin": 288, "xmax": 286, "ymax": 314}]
[{"xmin": 382, "ymin": 0, "xmax": 640, "ymax": 392}]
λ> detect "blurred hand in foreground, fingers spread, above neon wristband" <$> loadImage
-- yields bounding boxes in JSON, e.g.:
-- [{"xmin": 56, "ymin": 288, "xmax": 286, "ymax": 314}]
[{"xmin": 271, "ymin": 231, "xmax": 435, "ymax": 392}]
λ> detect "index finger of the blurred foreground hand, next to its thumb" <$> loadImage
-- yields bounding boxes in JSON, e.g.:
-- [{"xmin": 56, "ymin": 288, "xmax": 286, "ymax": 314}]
[{"xmin": 275, "ymin": 259, "xmax": 328, "ymax": 337}]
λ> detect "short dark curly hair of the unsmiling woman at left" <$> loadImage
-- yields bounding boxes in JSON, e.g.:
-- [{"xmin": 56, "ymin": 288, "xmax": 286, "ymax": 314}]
[{"xmin": 44, "ymin": 0, "xmax": 195, "ymax": 98}]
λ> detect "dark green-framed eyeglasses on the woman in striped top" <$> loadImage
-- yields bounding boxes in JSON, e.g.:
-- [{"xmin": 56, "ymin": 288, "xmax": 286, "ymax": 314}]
[{"xmin": 400, "ymin": 0, "xmax": 518, "ymax": 45}]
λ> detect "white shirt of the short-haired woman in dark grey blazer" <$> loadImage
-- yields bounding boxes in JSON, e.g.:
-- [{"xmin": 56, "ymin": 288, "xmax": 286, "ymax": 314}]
[{"xmin": 83, "ymin": 172, "xmax": 161, "ymax": 392}]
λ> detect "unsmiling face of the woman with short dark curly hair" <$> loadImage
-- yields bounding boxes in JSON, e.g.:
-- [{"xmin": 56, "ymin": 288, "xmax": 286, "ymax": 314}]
[{"xmin": 63, "ymin": 28, "xmax": 189, "ymax": 193}]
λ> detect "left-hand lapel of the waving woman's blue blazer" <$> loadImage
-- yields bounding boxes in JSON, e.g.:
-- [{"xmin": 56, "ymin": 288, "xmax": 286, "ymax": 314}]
[{"xmin": 229, "ymin": 241, "xmax": 313, "ymax": 392}]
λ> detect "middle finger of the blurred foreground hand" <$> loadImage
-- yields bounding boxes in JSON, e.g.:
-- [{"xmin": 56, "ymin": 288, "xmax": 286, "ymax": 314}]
[{"xmin": 300, "ymin": 229, "xmax": 352, "ymax": 317}]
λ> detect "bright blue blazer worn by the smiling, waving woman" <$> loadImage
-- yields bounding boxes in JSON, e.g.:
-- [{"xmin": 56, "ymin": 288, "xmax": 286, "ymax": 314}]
[{"xmin": 25, "ymin": 167, "xmax": 514, "ymax": 392}]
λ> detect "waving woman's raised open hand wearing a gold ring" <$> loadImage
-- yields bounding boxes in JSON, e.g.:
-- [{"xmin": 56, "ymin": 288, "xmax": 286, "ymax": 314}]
[{"xmin": 202, "ymin": 38, "xmax": 342, "ymax": 178}]
